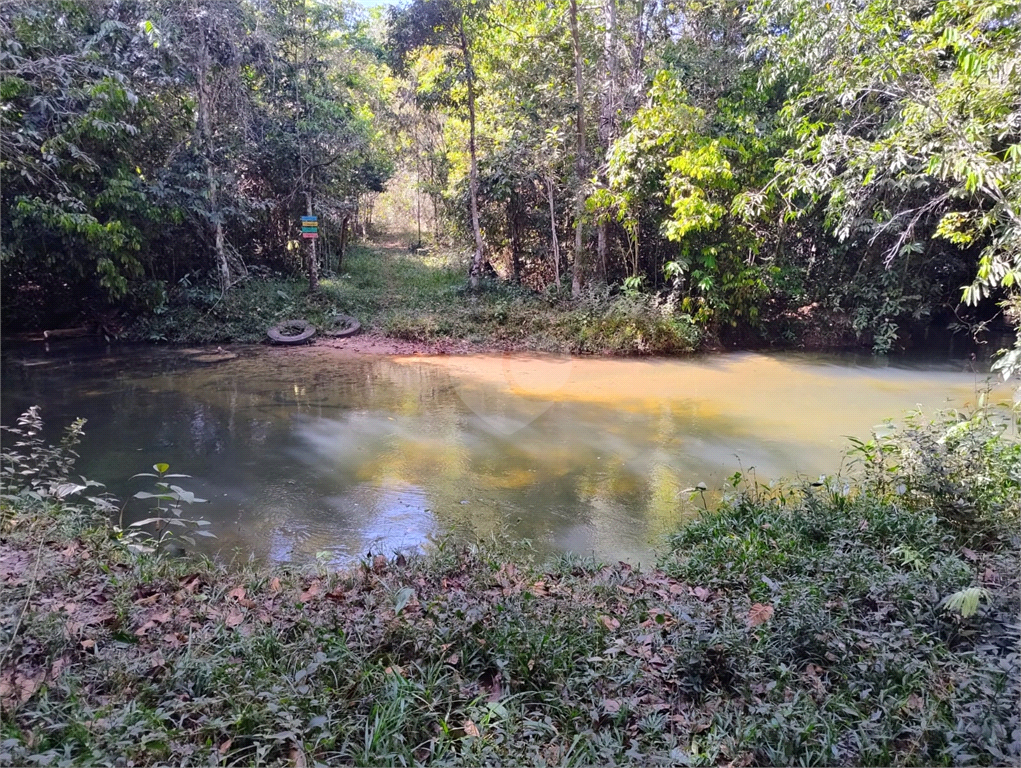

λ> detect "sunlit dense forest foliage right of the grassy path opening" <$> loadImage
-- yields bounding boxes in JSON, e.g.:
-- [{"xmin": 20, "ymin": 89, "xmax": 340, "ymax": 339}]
[{"xmin": 389, "ymin": 0, "xmax": 1021, "ymax": 350}]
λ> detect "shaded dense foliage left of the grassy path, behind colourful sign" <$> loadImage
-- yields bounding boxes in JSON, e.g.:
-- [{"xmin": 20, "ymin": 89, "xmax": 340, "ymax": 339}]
[{"xmin": 0, "ymin": 0, "xmax": 390, "ymax": 327}]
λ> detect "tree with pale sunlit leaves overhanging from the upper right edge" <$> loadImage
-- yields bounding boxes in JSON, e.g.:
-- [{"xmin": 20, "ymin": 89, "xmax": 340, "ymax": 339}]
[{"xmin": 750, "ymin": 0, "xmax": 1021, "ymax": 355}]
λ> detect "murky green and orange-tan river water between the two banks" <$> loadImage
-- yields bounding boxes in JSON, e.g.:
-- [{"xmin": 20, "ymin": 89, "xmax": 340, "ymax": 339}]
[{"xmin": 0, "ymin": 345, "xmax": 1009, "ymax": 564}]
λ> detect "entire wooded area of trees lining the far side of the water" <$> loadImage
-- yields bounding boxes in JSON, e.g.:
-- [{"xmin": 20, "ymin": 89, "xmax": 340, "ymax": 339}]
[{"xmin": 0, "ymin": 0, "xmax": 1021, "ymax": 357}]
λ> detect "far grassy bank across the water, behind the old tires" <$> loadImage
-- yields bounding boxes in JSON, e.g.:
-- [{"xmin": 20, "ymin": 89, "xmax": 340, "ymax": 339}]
[{"xmin": 127, "ymin": 245, "xmax": 700, "ymax": 354}]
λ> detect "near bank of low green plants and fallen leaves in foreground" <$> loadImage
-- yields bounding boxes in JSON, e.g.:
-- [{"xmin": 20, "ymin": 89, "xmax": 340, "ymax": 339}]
[{"xmin": 0, "ymin": 415, "xmax": 1021, "ymax": 766}]
